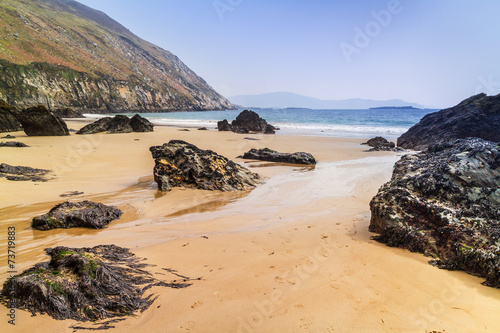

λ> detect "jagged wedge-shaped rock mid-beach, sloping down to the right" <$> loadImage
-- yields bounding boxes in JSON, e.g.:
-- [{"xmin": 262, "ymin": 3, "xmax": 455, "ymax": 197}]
[{"xmin": 150, "ymin": 140, "xmax": 261, "ymax": 191}]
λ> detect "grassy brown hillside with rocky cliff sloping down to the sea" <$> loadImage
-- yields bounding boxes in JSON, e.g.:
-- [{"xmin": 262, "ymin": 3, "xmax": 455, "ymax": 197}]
[{"xmin": 0, "ymin": 0, "xmax": 232, "ymax": 112}]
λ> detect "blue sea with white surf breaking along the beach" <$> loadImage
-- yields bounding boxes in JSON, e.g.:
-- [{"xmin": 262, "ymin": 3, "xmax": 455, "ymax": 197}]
[{"xmin": 85, "ymin": 107, "xmax": 437, "ymax": 140}]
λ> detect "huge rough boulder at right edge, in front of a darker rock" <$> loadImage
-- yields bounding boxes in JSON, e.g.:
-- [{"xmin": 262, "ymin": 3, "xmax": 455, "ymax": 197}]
[{"xmin": 370, "ymin": 138, "xmax": 500, "ymax": 287}]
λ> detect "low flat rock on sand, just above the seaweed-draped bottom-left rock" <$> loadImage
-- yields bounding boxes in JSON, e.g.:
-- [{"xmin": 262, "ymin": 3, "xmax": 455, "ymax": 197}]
[{"xmin": 31, "ymin": 200, "xmax": 122, "ymax": 230}]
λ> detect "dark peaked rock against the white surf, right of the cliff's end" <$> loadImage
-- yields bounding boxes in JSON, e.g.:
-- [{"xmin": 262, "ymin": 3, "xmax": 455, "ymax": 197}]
[{"xmin": 217, "ymin": 110, "xmax": 278, "ymax": 134}]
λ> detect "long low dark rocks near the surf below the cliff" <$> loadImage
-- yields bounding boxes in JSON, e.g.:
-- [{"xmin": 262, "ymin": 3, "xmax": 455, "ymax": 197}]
[{"xmin": 76, "ymin": 114, "xmax": 154, "ymax": 134}]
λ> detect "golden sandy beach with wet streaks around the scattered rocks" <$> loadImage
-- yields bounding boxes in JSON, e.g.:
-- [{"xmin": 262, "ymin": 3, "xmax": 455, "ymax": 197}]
[{"xmin": 0, "ymin": 121, "xmax": 500, "ymax": 332}]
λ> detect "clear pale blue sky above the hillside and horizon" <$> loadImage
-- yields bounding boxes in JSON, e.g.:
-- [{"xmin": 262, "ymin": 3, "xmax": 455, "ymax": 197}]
[{"xmin": 78, "ymin": 0, "xmax": 500, "ymax": 108}]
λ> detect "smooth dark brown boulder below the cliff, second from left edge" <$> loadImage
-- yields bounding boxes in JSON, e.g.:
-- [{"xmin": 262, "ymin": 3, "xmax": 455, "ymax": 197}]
[{"xmin": 16, "ymin": 105, "xmax": 69, "ymax": 136}]
